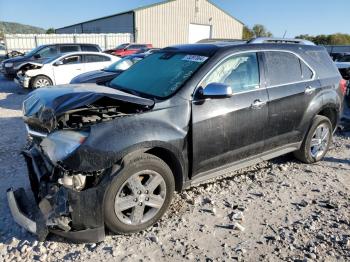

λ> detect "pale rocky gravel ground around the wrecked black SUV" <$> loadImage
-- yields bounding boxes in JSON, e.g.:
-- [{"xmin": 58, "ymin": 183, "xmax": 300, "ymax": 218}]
[{"xmin": 0, "ymin": 75, "xmax": 350, "ymax": 262}]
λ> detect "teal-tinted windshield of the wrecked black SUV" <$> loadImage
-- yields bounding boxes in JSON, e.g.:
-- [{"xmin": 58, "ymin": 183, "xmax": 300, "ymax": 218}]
[{"xmin": 111, "ymin": 52, "xmax": 208, "ymax": 98}]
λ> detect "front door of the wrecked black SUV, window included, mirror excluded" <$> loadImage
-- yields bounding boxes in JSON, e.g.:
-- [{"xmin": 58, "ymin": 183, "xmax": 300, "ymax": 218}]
[{"xmin": 192, "ymin": 53, "xmax": 268, "ymax": 176}]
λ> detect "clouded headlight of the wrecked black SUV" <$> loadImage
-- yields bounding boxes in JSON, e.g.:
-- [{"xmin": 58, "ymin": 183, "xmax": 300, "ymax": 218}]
[{"xmin": 40, "ymin": 131, "xmax": 88, "ymax": 164}]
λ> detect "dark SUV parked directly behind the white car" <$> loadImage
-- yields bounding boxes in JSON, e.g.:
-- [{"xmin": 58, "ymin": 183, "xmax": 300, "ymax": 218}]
[{"xmin": 1, "ymin": 44, "xmax": 102, "ymax": 78}]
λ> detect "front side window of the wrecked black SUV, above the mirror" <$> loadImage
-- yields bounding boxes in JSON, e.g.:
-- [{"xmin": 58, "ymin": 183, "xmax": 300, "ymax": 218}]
[{"xmin": 202, "ymin": 53, "xmax": 260, "ymax": 93}]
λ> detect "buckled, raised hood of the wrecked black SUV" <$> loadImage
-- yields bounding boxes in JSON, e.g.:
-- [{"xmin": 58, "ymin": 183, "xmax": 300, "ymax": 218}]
[{"xmin": 23, "ymin": 84, "xmax": 154, "ymax": 130}]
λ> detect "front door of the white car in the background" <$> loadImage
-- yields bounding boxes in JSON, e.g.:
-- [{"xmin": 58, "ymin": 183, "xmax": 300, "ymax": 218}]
[{"xmin": 53, "ymin": 55, "xmax": 84, "ymax": 85}]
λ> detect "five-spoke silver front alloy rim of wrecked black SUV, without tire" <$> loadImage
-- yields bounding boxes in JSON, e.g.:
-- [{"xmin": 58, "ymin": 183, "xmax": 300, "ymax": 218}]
[{"xmin": 114, "ymin": 170, "xmax": 166, "ymax": 225}]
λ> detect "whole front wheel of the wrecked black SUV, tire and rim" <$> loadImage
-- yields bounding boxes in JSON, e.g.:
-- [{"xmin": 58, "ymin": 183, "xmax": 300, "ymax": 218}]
[{"xmin": 104, "ymin": 153, "xmax": 175, "ymax": 234}]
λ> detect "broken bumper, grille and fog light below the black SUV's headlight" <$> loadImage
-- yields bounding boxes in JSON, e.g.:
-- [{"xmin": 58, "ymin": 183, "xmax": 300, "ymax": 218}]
[{"xmin": 7, "ymin": 138, "xmax": 105, "ymax": 242}]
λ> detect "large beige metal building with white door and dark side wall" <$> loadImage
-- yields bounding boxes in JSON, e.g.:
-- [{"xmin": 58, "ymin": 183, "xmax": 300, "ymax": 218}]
[{"xmin": 56, "ymin": 0, "xmax": 243, "ymax": 47}]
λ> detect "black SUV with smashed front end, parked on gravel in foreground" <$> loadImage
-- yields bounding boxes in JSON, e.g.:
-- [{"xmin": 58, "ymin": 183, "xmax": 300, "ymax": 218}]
[{"xmin": 7, "ymin": 39, "xmax": 345, "ymax": 241}]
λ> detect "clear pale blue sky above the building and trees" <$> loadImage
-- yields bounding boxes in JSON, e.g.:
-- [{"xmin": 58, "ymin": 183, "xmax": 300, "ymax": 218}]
[{"xmin": 0, "ymin": 0, "xmax": 350, "ymax": 37}]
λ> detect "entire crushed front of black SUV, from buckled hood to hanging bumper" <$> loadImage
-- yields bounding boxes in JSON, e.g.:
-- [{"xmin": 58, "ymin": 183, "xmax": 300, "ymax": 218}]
[{"xmin": 7, "ymin": 85, "xmax": 152, "ymax": 242}]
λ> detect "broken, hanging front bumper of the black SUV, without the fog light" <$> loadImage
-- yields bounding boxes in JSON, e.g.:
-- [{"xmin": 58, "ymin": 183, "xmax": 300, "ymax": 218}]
[{"xmin": 7, "ymin": 147, "xmax": 105, "ymax": 243}]
